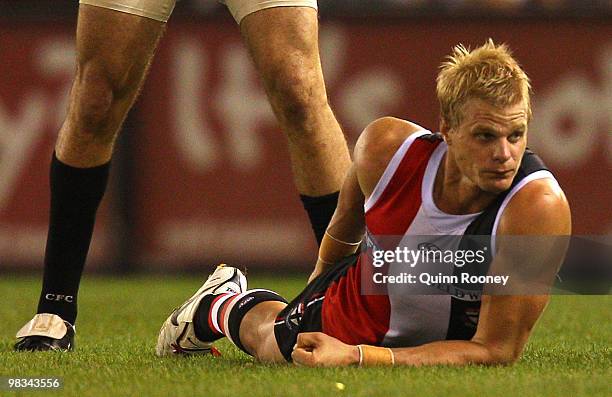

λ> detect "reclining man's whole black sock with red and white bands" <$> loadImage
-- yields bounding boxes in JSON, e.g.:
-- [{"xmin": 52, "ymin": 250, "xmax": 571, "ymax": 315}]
[{"xmin": 193, "ymin": 289, "xmax": 287, "ymax": 354}]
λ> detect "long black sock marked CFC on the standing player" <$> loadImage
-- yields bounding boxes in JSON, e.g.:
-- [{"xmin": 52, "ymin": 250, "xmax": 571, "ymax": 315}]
[{"xmin": 38, "ymin": 153, "xmax": 110, "ymax": 324}]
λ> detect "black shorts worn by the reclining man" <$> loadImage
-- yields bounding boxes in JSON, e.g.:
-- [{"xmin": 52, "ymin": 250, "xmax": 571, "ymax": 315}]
[{"xmin": 274, "ymin": 254, "xmax": 359, "ymax": 362}]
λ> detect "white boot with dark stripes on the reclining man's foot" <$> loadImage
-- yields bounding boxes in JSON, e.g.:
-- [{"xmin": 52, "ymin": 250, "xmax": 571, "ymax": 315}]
[{"xmin": 155, "ymin": 264, "xmax": 247, "ymax": 357}]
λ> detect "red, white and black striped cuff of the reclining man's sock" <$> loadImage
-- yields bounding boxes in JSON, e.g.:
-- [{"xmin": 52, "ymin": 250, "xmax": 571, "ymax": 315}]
[{"xmin": 220, "ymin": 289, "xmax": 287, "ymax": 354}]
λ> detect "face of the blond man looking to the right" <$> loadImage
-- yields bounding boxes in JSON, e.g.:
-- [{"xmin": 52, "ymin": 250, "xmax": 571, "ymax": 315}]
[{"xmin": 442, "ymin": 99, "xmax": 527, "ymax": 193}]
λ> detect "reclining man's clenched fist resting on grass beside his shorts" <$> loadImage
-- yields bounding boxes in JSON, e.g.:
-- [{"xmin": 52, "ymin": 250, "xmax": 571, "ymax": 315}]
[{"xmin": 291, "ymin": 332, "xmax": 359, "ymax": 367}]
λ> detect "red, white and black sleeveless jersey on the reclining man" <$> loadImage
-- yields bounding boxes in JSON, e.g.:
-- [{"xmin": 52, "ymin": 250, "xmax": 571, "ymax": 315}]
[{"xmin": 321, "ymin": 130, "xmax": 554, "ymax": 346}]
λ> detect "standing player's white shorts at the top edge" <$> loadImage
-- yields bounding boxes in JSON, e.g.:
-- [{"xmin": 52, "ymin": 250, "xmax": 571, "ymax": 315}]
[{"xmin": 79, "ymin": 0, "xmax": 317, "ymax": 24}]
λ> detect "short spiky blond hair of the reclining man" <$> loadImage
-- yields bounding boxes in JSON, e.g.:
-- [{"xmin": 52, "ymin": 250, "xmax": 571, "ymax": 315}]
[{"xmin": 436, "ymin": 39, "xmax": 531, "ymax": 128}]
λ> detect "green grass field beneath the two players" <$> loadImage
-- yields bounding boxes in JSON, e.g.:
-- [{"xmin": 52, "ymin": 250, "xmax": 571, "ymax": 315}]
[{"xmin": 0, "ymin": 276, "xmax": 612, "ymax": 397}]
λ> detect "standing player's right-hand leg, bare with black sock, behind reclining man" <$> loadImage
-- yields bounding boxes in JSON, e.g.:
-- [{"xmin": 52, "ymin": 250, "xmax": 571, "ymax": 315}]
[{"xmin": 237, "ymin": 4, "xmax": 351, "ymax": 243}]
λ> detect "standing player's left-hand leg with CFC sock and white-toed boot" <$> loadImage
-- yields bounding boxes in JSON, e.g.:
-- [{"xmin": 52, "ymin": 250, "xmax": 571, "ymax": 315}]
[{"xmin": 15, "ymin": 0, "xmax": 169, "ymax": 350}]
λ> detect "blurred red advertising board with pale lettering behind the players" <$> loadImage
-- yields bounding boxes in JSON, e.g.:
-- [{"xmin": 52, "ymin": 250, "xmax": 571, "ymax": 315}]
[{"xmin": 0, "ymin": 3, "xmax": 612, "ymax": 271}]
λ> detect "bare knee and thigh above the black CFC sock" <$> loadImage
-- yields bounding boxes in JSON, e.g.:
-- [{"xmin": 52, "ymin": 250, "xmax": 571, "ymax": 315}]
[{"xmin": 55, "ymin": 5, "xmax": 165, "ymax": 168}]
